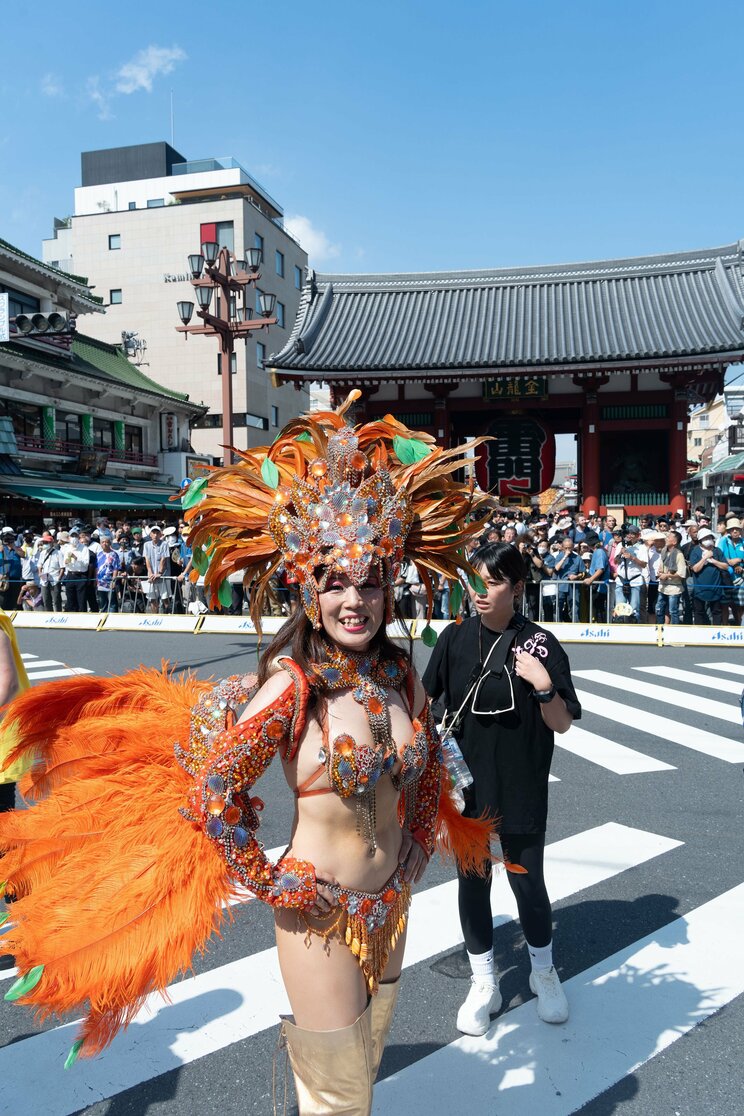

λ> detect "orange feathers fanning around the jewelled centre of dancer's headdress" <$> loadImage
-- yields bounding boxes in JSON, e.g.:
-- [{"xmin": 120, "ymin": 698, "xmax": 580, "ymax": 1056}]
[{"xmin": 185, "ymin": 391, "xmax": 489, "ymax": 632}]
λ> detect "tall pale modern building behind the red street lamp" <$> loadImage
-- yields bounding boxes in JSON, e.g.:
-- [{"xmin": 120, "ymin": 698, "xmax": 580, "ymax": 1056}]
[{"xmin": 42, "ymin": 143, "xmax": 309, "ymax": 459}]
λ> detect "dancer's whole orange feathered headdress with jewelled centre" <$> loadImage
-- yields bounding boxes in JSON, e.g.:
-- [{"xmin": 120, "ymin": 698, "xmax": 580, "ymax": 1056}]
[{"xmin": 182, "ymin": 391, "xmax": 487, "ymax": 632}]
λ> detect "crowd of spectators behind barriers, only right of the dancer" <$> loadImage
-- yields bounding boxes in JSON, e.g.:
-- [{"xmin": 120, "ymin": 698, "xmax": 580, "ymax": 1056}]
[{"xmin": 396, "ymin": 508, "xmax": 744, "ymax": 625}]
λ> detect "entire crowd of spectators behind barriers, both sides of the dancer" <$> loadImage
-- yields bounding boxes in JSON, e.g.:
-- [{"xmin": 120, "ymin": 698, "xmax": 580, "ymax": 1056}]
[{"xmin": 0, "ymin": 508, "xmax": 744, "ymax": 625}]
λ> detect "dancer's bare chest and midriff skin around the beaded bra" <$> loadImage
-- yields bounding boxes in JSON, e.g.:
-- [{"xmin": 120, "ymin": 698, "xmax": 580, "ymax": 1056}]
[{"xmin": 284, "ymin": 691, "xmax": 414, "ymax": 892}]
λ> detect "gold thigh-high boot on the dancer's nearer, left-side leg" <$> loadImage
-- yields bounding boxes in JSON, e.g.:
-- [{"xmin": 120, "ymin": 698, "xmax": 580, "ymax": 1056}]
[{"xmin": 282, "ymin": 1004, "xmax": 374, "ymax": 1116}]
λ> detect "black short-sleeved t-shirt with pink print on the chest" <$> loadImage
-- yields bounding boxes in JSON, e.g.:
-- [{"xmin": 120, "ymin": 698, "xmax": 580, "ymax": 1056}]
[{"xmin": 423, "ymin": 613, "xmax": 581, "ymax": 834}]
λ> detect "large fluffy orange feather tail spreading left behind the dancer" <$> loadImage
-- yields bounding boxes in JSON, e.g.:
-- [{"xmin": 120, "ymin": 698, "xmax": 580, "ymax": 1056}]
[{"xmin": 0, "ymin": 668, "xmax": 233, "ymax": 1056}]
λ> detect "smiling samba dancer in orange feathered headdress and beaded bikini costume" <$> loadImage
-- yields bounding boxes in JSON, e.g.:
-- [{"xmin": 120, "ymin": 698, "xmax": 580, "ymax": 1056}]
[{"xmin": 0, "ymin": 395, "xmax": 490, "ymax": 1116}]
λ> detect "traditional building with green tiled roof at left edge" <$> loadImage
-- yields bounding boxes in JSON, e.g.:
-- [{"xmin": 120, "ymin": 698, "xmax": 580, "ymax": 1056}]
[{"xmin": 0, "ymin": 241, "xmax": 209, "ymax": 526}]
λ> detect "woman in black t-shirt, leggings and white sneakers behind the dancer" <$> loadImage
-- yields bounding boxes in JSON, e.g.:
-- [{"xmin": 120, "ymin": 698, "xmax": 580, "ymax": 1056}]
[{"xmin": 423, "ymin": 542, "xmax": 581, "ymax": 1035}]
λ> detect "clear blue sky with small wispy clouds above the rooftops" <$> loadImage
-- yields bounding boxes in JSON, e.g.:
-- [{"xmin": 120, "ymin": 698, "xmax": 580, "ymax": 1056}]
[{"xmin": 0, "ymin": 0, "xmax": 744, "ymax": 271}]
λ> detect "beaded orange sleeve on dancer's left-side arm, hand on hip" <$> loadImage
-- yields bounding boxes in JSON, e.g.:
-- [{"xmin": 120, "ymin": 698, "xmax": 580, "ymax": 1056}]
[{"xmin": 181, "ymin": 661, "xmax": 317, "ymax": 907}]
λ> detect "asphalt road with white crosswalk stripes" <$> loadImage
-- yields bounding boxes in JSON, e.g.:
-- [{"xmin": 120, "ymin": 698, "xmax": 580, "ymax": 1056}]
[{"xmin": 0, "ymin": 631, "xmax": 744, "ymax": 1116}]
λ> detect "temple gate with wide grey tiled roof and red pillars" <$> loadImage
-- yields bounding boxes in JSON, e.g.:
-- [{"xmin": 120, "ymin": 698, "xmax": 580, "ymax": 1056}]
[{"xmin": 270, "ymin": 241, "xmax": 744, "ymax": 516}]
